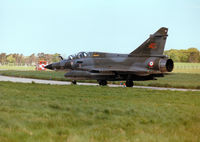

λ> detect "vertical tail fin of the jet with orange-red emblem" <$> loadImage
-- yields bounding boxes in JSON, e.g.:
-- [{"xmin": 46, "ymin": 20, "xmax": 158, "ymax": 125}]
[{"xmin": 129, "ymin": 27, "xmax": 168, "ymax": 56}]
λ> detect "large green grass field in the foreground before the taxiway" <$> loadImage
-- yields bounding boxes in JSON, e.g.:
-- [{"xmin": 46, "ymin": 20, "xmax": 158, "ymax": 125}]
[{"xmin": 0, "ymin": 82, "xmax": 200, "ymax": 142}]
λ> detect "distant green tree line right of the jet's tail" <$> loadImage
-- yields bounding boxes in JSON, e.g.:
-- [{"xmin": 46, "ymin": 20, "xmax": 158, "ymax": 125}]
[{"xmin": 164, "ymin": 48, "xmax": 200, "ymax": 63}]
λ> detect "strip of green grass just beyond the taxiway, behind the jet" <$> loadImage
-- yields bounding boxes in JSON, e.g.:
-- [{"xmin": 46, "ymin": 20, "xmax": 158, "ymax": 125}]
[{"xmin": 0, "ymin": 70, "xmax": 200, "ymax": 89}]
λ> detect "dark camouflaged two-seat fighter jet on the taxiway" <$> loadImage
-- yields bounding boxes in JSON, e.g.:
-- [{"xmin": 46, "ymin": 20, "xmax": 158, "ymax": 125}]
[{"xmin": 45, "ymin": 27, "xmax": 174, "ymax": 87}]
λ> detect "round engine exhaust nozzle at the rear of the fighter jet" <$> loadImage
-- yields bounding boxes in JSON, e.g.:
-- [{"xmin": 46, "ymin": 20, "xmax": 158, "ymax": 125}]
[{"xmin": 159, "ymin": 59, "xmax": 174, "ymax": 72}]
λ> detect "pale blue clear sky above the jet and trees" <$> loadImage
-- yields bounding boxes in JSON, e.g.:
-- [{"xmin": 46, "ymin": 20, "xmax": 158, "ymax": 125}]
[{"xmin": 0, "ymin": 0, "xmax": 200, "ymax": 56}]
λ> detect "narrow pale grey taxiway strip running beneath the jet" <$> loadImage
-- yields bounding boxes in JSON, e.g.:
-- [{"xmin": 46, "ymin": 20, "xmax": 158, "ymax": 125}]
[{"xmin": 0, "ymin": 75, "xmax": 200, "ymax": 91}]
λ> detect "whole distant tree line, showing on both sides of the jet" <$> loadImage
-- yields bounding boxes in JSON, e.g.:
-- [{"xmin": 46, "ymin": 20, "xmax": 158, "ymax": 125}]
[{"xmin": 0, "ymin": 48, "xmax": 200, "ymax": 65}]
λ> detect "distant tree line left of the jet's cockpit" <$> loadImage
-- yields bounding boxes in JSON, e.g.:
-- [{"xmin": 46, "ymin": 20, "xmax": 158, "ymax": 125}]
[{"xmin": 0, "ymin": 53, "xmax": 60, "ymax": 66}]
